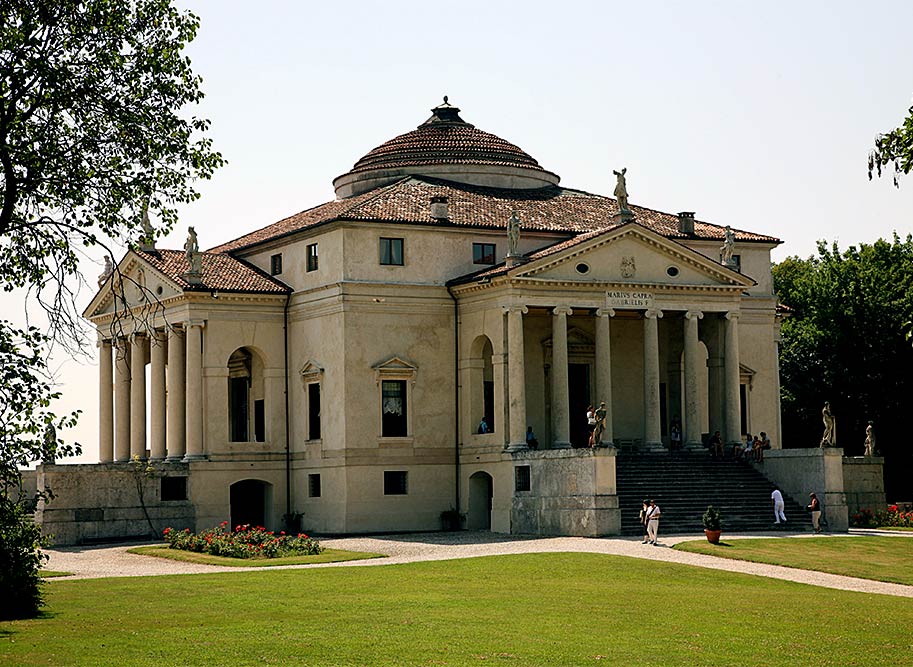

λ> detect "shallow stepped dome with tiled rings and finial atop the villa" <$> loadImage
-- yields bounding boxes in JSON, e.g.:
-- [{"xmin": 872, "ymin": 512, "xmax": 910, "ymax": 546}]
[{"xmin": 333, "ymin": 97, "xmax": 559, "ymax": 197}]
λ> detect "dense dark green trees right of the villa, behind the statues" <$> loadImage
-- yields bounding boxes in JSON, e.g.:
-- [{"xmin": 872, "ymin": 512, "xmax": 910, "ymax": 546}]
[{"xmin": 773, "ymin": 235, "xmax": 913, "ymax": 497}]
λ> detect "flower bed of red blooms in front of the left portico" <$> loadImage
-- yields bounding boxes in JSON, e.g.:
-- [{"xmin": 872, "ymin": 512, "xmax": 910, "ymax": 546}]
[{"xmin": 164, "ymin": 521, "xmax": 323, "ymax": 558}]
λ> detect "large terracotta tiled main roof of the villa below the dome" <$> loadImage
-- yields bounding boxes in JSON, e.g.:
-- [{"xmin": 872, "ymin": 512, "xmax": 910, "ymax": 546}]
[{"xmin": 212, "ymin": 176, "xmax": 780, "ymax": 252}]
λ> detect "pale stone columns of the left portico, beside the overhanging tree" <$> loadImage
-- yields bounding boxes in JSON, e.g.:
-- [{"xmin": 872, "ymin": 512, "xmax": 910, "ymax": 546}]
[{"xmin": 98, "ymin": 320, "xmax": 205, "ymax": 463}]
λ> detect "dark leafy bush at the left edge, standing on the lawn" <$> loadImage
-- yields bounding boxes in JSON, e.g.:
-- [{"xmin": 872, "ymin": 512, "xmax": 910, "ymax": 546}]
[{"xmin": 0, "ymin": 494, "xmax": 48, "ymax": 620}]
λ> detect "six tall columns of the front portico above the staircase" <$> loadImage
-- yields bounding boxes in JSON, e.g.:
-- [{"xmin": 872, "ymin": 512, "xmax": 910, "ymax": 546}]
[{"xmin": 504, "ymin": 305, "xmax": 741, "ymax": 451}]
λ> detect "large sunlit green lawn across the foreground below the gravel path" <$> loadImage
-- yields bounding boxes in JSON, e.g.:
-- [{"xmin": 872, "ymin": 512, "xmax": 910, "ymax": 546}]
[{"xmin": 0, "ymin": 554, "xmax": 913, "ymax": 667}]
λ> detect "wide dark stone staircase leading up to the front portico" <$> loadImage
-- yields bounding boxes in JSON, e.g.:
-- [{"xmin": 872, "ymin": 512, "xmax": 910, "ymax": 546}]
[{"xmin": 616, "ymin": 452, "xmax": 811, "ymax": 535}]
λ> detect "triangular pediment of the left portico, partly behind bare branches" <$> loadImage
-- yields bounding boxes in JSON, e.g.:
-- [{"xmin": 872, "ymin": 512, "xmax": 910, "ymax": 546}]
[{"xmin": 83, "ymin": 251, "xmax": 183, "ymax": 319}]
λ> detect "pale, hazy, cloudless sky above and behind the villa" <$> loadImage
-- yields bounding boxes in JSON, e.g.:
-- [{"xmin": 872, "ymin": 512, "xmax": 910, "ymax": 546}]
[{"xmin": 7, "ymin": 0, "xmax": 913, "ymax": 461}]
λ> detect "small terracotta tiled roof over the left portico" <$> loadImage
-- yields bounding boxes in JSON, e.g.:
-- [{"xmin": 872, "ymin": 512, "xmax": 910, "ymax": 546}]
[{"xmin": 136, "ymin": 250, "xmax": 291, "ymax": 294}]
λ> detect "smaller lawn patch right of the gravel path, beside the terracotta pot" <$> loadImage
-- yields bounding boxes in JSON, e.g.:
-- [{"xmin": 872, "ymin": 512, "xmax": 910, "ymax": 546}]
[{"xmin": 675, "ymin": 535, "xmax": 913, "ymax": 586}]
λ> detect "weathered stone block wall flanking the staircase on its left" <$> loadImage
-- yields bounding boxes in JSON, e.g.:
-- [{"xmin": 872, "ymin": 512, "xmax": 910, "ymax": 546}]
[{"xmin": 510, "ymin": 447, "xmax": 621, "ymax": 537}]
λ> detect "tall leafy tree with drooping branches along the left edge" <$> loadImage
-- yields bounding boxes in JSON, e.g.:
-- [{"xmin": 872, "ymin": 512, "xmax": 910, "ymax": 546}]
[{"xmin": 0, "ymin": 0, "xmax": 223, "ymax": 615}]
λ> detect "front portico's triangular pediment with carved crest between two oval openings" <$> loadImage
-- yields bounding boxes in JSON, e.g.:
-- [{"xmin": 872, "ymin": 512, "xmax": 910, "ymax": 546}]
[{"xmin": 510, "ymin": 223, "xmax": 754, "ymax": 287}]
